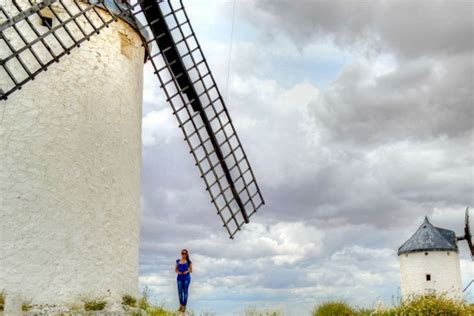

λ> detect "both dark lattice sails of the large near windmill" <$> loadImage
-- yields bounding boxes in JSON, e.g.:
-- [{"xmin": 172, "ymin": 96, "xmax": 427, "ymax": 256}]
[{"xmin": 0, "ymin": 0, "xmax": 265, "ymax": 238}]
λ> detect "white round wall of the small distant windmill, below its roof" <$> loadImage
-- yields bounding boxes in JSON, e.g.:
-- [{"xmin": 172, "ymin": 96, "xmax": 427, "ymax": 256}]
[{"xmin": 400, "ymin": 251, "xmax": 463, "ymax": 299}]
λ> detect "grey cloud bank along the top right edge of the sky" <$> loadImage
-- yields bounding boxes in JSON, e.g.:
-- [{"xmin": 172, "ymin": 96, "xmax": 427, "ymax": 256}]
[{"xmin": 245, "ymin": 0, "xmax": 474, "ymax": 58}]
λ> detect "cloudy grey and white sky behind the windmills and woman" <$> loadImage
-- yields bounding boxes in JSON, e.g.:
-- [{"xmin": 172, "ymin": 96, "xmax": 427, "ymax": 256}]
[{"xmin": 140, "ymin": 0, "xmax": 474, "ymax": 315}]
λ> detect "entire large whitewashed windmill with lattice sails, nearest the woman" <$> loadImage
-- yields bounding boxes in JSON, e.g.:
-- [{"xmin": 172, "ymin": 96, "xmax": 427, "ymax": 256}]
[{"xmin": 0, "ymin": 0, "xmax": 264, "ymax": 310}]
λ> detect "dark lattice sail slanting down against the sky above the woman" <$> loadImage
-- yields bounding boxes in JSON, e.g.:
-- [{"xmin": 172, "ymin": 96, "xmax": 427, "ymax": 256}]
[{"xmin": 135, "ymin": 0, "xmax": 264, "ymax": 238}]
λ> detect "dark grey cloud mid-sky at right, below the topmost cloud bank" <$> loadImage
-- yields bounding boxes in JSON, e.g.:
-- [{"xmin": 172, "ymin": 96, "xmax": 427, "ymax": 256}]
[{"xmin": 310, "ymin": 55, "xmax": 474, "ymax": 146}]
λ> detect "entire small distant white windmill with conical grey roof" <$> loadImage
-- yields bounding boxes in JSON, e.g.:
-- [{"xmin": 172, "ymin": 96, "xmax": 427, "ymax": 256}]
[{"xmin": 398, "ymin": 210, "xmax": 474, "ymax": 300}]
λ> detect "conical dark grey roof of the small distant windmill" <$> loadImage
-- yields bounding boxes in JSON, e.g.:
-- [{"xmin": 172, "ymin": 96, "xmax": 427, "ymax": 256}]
[{"xmin": 398, "ymin": 217, "xmax": 458, "ymax": 255}]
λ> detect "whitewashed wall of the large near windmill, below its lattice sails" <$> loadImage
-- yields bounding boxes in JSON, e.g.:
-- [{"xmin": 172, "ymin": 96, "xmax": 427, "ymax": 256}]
[{"xmin": 0, "ymin": 0, "xmax": 144, "ymax": 304}]
